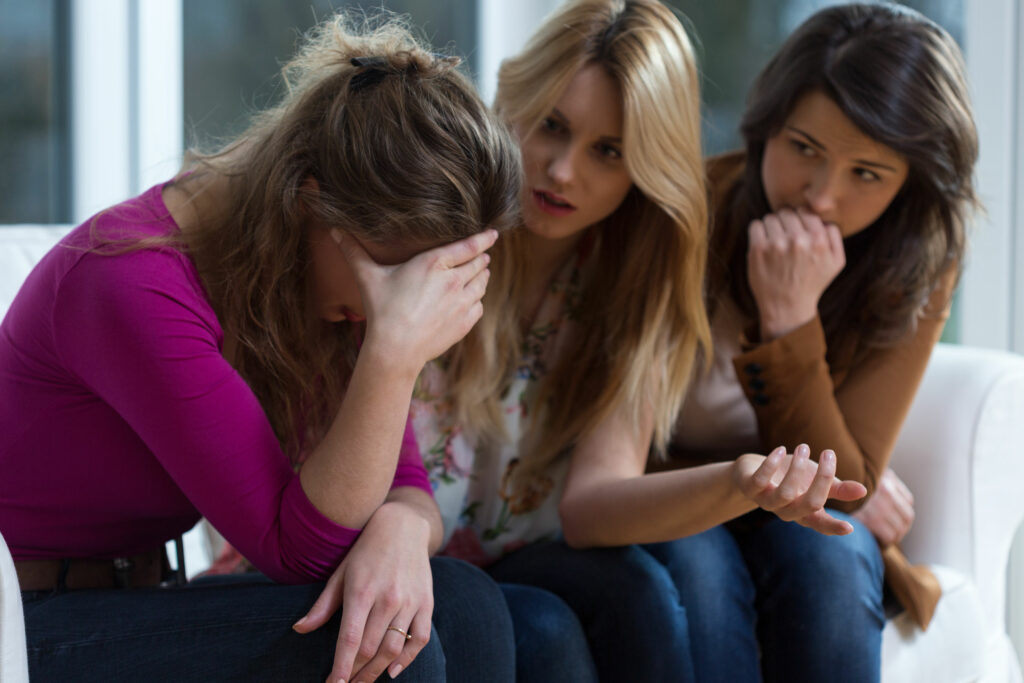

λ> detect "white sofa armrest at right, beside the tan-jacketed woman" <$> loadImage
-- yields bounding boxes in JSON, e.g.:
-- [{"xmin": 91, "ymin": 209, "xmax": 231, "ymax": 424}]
[{"xmin": 892, "ymin": 344, "xmax": 1024, "ymax": 632}]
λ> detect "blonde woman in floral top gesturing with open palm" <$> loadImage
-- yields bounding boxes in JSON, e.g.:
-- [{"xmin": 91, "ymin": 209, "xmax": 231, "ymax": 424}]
[{"xmin": 413, "ymin": 0, "xmax": 863, "ymax": 681}]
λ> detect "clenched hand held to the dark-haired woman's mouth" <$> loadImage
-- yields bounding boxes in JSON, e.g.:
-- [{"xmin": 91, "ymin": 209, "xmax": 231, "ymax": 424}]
[{"xmin": 746, "ymin": 209, "xmax": 846, "ymax": 341}]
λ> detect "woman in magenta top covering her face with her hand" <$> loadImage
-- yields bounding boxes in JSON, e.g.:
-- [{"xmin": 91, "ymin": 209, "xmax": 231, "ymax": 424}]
[{"xmin": 0, "ymin": 15, "xmax": 521, "ymax": 681}]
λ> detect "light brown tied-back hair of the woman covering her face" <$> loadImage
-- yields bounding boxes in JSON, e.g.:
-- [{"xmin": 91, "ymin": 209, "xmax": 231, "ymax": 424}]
[{"xmin": 169, "ymin": 13, "xmax": 521, "ymax": 458}]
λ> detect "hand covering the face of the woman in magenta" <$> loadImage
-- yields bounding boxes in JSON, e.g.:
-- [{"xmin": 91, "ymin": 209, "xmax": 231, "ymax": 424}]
[{"xmin": 331, "ymin": 229, "xmax": 498, "ymax": 374}]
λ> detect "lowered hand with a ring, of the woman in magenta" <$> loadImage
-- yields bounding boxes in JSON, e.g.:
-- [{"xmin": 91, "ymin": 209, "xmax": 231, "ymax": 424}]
[{"xmin": 293, "ymin": 503, "xmax": 434, "ymax": 683}]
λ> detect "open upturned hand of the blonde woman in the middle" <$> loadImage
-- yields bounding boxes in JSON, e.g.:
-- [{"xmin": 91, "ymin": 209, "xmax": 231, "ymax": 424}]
[{"xmin": 732, "ymin": 443, "xmax": 867, "ymax": 536}]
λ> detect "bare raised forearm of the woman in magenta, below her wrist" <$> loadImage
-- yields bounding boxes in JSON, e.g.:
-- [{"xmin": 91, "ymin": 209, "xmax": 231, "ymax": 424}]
[{"xmin": 300, "ymin": 341, "xmax": 416, "ymax": 528}]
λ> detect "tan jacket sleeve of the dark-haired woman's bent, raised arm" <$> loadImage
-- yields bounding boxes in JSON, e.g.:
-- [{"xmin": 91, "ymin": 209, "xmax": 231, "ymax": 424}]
[{"xmin": 733, "ymin": 268, "xmax": 955, "ymax": 511}]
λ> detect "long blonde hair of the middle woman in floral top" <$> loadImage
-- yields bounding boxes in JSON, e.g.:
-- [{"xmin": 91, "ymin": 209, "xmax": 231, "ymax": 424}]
[{"xmin": 450, "ymin": 0, "xmax": 711, "ymax": 482}]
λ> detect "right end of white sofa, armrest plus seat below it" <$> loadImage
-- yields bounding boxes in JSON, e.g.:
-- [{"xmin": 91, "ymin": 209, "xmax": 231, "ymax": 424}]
[{"xmin": 882, "ymin": 344, "xmax": 1024, "ymax": 683}]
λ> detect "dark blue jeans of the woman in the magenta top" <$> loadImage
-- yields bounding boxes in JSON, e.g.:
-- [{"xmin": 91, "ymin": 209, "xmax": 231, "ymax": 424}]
[{"xmin": 23, "ymin": 558, "xmax": 515, "ymax": 683}]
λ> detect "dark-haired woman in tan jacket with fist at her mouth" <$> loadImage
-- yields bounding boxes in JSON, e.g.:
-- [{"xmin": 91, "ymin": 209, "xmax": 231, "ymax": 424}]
[{"xmin": 660, "ymin": 4, "xmax": 977, "ymax": 681}]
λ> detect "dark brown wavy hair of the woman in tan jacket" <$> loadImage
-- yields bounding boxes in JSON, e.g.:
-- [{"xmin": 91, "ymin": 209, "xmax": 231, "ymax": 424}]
[{"xmin": 709, "ymin": 4, "xmax": 978, "ymax": 365}]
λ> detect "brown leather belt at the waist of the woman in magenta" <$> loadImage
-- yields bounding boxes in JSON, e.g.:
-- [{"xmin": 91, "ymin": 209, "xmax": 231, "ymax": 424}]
[{"xmin": 14, "ymin": 548, "xmax": 169, "ymax": 591}]
